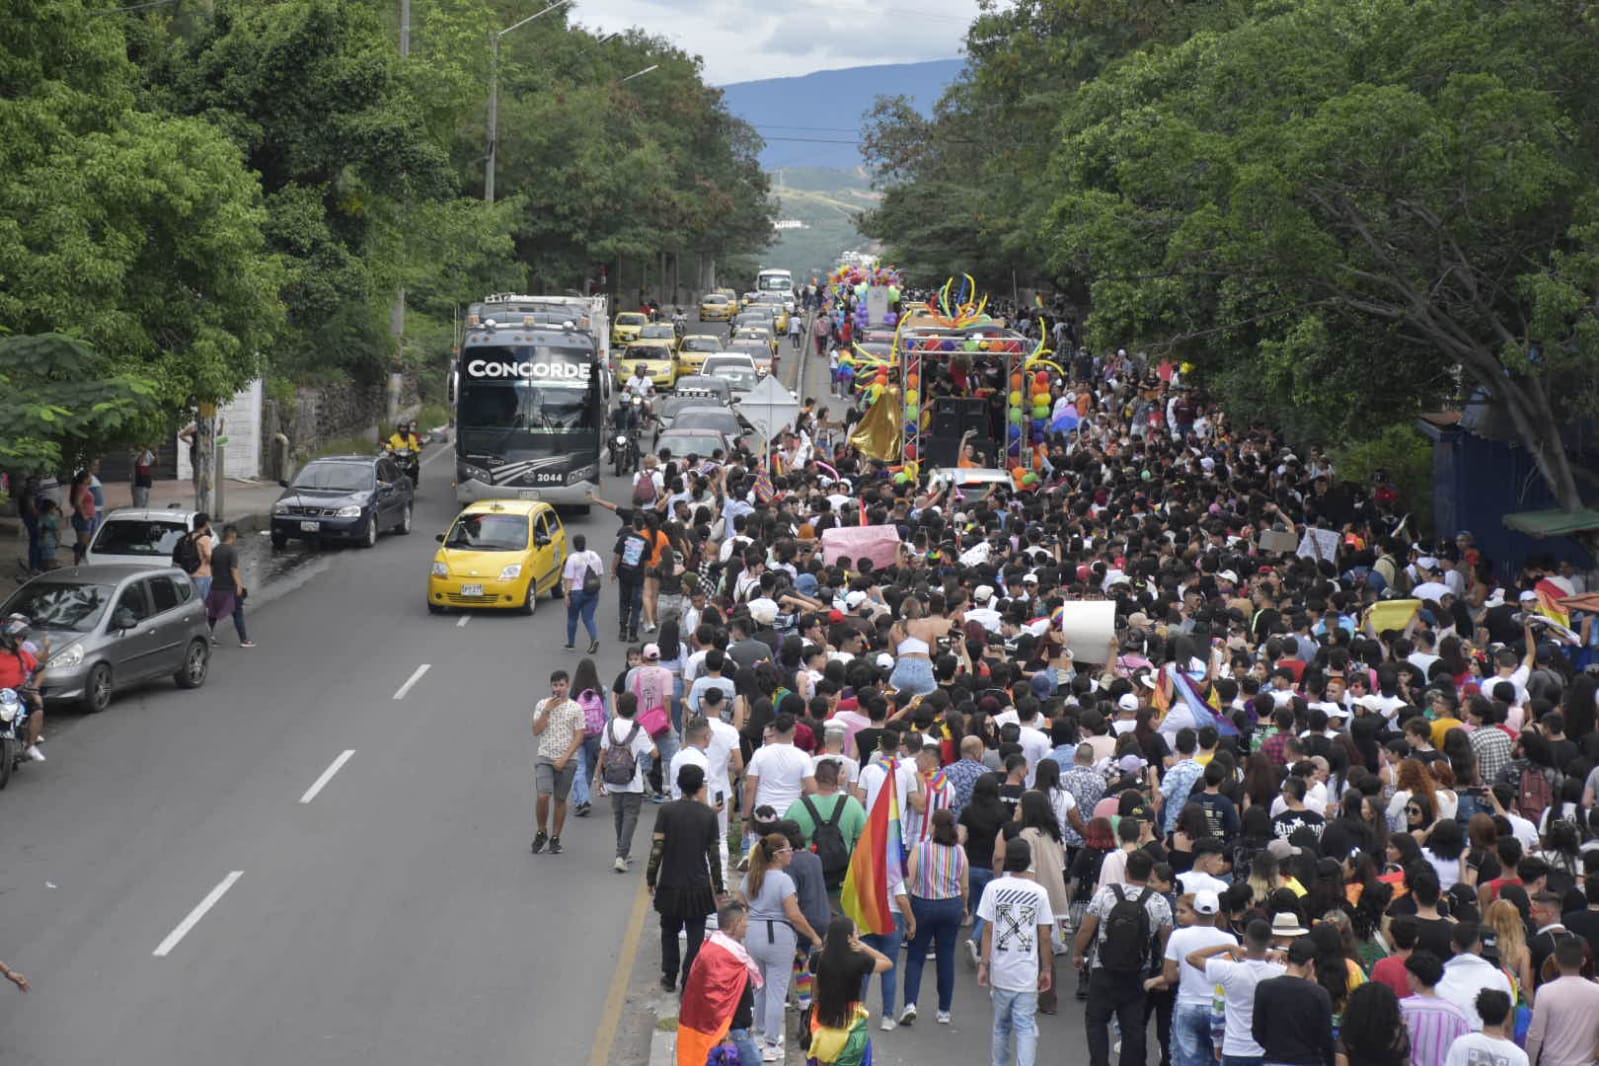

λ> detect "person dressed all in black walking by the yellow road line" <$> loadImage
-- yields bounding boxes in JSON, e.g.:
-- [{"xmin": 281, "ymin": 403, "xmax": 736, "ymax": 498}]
[{"xmin": 644, "ymin": 762, "xmax": 726, "ymax": 992}]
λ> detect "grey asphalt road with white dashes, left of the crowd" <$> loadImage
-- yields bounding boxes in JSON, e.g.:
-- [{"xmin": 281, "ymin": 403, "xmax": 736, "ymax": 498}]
[{"xmin": 0, "ymin": 428, "xmax": 684, "ymax": 1066}]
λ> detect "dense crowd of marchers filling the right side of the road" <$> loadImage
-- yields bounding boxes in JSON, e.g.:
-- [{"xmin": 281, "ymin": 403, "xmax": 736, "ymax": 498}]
[{"xmin": 532, "ymin": 294, "xmax": 1599, "ymax": 1066}]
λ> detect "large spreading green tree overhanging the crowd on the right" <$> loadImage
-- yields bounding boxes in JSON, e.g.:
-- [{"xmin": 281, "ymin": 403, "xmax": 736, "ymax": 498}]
[{"xmin": 875, "ymin": 0, "xmax": 1599, "ymax": 507}]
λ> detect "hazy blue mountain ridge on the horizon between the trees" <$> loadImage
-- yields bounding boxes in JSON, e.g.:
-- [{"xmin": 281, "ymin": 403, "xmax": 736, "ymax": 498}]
[{"xmin": 723, "ymin": 59, "xmax": 966, "ymax": 171}]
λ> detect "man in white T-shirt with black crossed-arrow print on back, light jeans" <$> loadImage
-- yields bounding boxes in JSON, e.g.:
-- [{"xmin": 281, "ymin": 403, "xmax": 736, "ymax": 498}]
[{"xmin": 977, "ymin": 837, "xmax": 1055, "ymax": 1066}]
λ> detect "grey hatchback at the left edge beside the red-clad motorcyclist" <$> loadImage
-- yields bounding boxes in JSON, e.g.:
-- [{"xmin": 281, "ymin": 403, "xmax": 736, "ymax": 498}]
[{"xmin": 0, "ymin": 566, "xmax": 211, "ymax": 711}]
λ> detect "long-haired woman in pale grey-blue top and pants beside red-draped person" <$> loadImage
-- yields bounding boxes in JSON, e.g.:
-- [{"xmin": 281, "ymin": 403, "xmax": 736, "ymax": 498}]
[{"xmin": 739, "ymin": 833, "xmax": 822, "ymax": 1063}]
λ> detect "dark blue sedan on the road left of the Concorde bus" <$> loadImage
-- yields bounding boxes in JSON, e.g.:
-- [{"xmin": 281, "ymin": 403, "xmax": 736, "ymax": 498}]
[{"xmin": 272, "ymin": 455, "xmax": 414, "ymax": 548}]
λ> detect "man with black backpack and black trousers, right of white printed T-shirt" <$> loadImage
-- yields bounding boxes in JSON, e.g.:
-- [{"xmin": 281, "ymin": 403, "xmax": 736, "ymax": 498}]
[{"xmin": 1073, "ymin": 850, "xmax": 1172, "ymax": 1066}]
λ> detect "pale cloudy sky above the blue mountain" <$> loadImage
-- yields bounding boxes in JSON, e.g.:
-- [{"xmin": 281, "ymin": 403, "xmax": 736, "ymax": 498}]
[{"xmin": 572, "ymin": 0, "xmax": 977, "ymax": 85}]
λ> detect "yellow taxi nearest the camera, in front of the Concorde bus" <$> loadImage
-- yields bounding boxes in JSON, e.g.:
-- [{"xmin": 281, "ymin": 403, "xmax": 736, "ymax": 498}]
[{"xmin": 427, "ymin": 500, "xmax": 566, "ymax": 614}]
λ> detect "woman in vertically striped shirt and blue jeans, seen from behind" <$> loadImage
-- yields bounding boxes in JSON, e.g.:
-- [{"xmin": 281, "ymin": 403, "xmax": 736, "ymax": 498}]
[{"xmin": 900, "ymin": 807, "xmax": 971, "ymax": 1026}]
